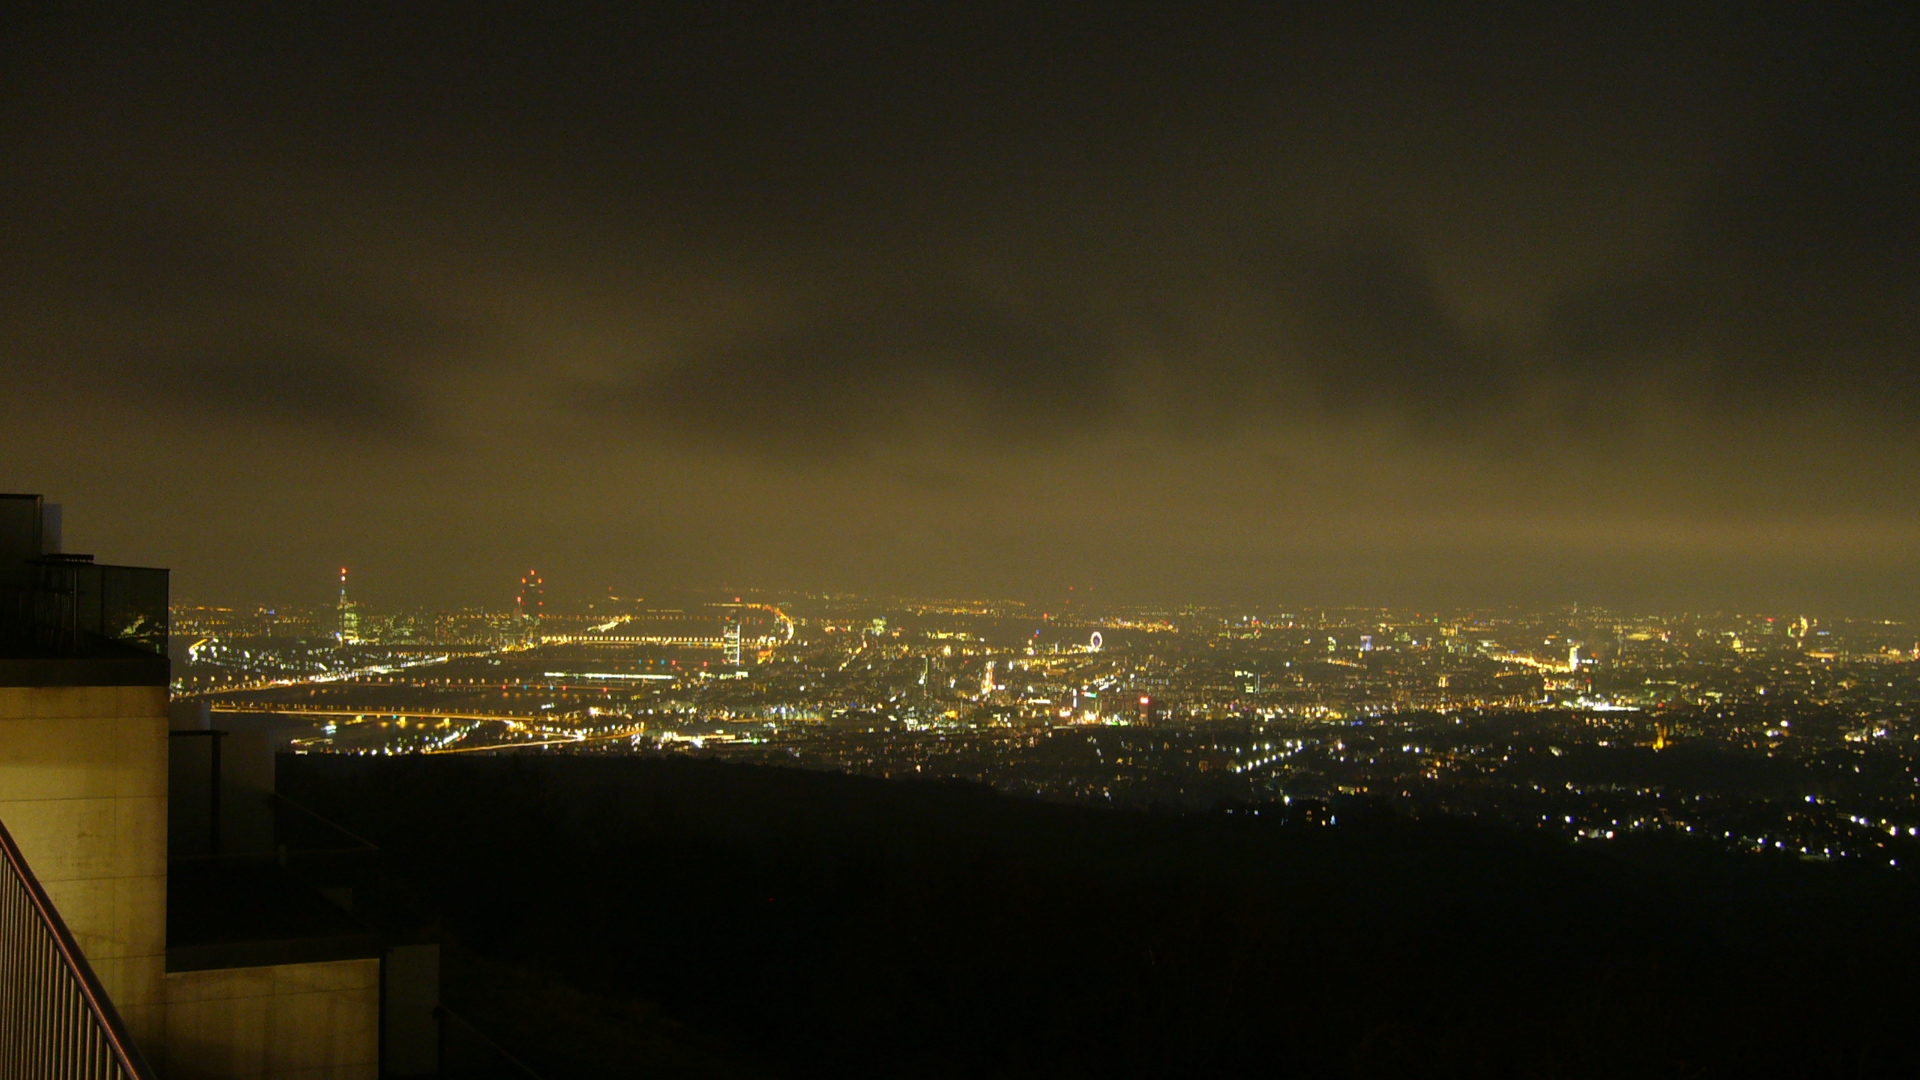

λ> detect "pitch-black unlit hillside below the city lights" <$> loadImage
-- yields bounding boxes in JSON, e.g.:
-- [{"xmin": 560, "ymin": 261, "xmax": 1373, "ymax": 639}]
[{"xmin": 280, "ymin": 755, "xmax": 1920, "ymax": 1078}]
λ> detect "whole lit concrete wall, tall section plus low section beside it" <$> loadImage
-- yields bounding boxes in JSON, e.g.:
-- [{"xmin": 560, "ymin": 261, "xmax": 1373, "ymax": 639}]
[{"xmin": 0, "ymin": 686, "xmax": 380, "ymax": 1080}]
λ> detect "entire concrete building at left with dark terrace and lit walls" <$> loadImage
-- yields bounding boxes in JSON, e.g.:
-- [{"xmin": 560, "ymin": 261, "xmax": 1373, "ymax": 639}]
[{"xmin": 0, "ymin": 496, "xmax": 420, "ymax": 1080}]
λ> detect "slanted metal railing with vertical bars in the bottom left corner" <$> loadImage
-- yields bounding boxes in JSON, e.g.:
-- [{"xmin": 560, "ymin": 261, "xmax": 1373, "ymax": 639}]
[{"xmin": 0, "ymin": 810, "xmax": 156, "ymax": 1080}]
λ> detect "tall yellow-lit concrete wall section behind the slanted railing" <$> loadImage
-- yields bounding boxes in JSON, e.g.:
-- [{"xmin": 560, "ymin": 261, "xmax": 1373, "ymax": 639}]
[{"xmin": 0, "ymin": 686, "xmax": 167, "ymax": 1049}]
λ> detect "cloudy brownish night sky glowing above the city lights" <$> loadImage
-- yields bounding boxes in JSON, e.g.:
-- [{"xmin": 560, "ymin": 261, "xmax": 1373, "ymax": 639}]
[{"xmin": 0, "ymin": 2, "xmax": 1920, "ymax": 619}]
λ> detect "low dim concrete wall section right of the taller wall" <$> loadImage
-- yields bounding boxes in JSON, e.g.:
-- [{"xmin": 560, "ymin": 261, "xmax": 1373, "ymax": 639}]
[{"xmin": 156, "ymin": 959, "xmax": 380, "ymax": 1080}]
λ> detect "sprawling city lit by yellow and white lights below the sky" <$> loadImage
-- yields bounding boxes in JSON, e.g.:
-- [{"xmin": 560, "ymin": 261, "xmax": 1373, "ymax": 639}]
[{"xmin": 173, "ymin": 580, "xmax": 1920, "ymax": 869}]
